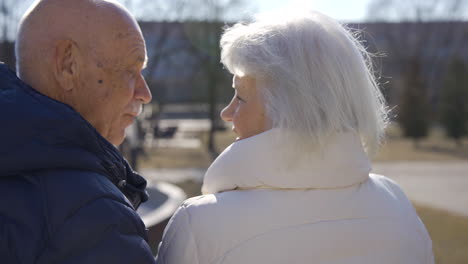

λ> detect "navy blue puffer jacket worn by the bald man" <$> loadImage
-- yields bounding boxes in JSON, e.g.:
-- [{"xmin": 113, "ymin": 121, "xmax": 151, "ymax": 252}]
[{"xmin": 0, "ymin": 65, "xmax": 154, "ymax": 264}]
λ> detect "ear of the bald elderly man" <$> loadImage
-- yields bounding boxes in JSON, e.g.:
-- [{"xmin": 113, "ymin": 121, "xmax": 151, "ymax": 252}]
[{"xmin": 54, "ymin": 40, "xmax": 81, "ymax": 91}]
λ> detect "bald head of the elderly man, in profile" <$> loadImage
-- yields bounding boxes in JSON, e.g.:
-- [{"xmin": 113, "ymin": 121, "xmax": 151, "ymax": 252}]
[{"xmin": 16, "ymin": 0, "xmax": 151, "ymax": 145}]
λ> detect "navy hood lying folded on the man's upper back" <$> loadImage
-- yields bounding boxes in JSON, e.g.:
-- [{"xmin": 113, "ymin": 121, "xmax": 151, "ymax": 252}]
[{"xmin": 0, "ymin": 64, "xmax": 148, "ymax": 208}]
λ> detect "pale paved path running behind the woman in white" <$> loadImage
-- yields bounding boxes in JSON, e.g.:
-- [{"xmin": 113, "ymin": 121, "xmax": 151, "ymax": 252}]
[{"xmin": 141, "ymin": 161, "xmax": 468, "ymax": 217}]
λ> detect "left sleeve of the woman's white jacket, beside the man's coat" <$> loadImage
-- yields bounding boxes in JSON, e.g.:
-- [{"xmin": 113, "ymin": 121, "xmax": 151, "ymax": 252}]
[{"xmin": 156, "ymin": 205, "xmax": 199, "ymax": 264}]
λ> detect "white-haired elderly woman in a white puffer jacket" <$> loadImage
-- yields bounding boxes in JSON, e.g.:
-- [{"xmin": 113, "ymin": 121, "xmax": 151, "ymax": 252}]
[{"xmin": 157, "ymin": 12, "xmax": 433, "ymax": 264}]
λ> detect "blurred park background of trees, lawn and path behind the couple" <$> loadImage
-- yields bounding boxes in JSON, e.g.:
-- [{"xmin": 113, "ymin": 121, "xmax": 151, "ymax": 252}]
[{"xmin": 0, "ymin": 0, "xmax": 468, "ymax": 264}]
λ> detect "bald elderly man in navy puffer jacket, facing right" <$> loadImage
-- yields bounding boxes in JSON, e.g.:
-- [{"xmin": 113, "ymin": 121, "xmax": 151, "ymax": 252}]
[{"xmin": 0, "ymin": 0, "xmax": 154, "ymax": 264}]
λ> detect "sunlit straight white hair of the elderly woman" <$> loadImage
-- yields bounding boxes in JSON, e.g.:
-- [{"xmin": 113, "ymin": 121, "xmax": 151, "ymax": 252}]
[{"xmin": 220, "ymin": 12, "xmax": 388, "ymax": 153}]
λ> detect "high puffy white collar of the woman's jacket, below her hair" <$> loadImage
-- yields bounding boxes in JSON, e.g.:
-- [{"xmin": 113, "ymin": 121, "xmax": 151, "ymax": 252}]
[{"xmin": 202, "ymin": 129, "xmax": 371, "ymax": 194}]
